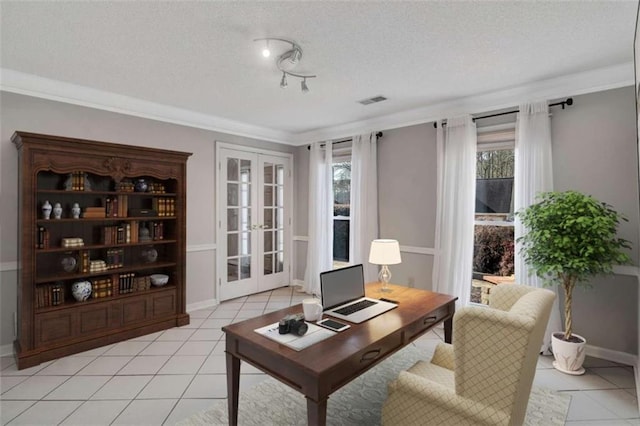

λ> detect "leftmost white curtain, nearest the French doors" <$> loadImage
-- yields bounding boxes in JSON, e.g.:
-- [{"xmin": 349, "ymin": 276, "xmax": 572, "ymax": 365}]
[{"xmin": 303, "ymin": 142, "xmax": 333, "ymax": 296}]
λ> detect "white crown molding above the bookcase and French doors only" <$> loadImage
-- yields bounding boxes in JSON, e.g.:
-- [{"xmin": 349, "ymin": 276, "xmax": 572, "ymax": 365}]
[{"xmin": 0, "ymin": 68, "xmax": 292, "ymax": 145}]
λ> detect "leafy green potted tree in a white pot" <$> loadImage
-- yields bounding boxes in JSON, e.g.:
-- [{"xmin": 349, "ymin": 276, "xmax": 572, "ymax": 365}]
[{"xmin": 517, "ymin": 191, "xmax": 631, "ymax": 374}]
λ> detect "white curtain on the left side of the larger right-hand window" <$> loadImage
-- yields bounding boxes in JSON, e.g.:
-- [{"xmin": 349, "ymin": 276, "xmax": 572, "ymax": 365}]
[{"xmin": 433, "ymin": 115, "xmax": 477, "ymax": 306}]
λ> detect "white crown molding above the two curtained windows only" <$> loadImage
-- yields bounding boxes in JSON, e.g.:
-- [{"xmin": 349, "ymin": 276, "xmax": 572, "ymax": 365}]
[{"xmin": 294, "ymin": 62, "xmax": 634, "ymax": 145}]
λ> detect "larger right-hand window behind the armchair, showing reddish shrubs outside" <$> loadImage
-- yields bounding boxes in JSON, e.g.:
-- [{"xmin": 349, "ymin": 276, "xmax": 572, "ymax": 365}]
[{"xmin": 471, "ymin": 137, "xmax": 515, "ymax": 304}]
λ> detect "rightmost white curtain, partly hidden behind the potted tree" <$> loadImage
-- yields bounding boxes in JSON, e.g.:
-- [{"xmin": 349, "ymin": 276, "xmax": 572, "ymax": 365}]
[{"xmin": 513, "ymin": 101, "xmax": 562, "ymax": 354}]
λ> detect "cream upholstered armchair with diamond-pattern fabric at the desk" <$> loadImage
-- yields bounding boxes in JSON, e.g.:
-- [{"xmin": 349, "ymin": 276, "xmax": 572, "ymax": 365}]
[{"xmin": 382, "ymin": 284, "xmax": 555, "ymax": 426}]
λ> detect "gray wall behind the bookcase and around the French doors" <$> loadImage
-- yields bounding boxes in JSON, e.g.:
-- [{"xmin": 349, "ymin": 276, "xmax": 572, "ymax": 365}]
[{"xmin": 0, "ymin": 92, "xmax": 294, "ymax": 352}]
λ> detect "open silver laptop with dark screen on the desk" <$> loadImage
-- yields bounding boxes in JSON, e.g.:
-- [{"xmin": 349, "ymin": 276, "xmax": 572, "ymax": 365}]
[{"xmin": 320, "ymin": 264, "xmax": 398, "ymax": 324}]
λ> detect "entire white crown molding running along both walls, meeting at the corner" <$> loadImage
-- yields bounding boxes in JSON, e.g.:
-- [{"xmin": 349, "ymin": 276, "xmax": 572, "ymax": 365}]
[{"xmin": 0, "ymin": 62, "xmax": 634, "ymax": 146}]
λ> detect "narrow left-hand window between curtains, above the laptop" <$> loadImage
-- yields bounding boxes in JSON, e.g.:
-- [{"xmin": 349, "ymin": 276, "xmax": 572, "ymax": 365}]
[{"xmin": 333, "ymin": 157, "xmax": 351, "ymax": 268}]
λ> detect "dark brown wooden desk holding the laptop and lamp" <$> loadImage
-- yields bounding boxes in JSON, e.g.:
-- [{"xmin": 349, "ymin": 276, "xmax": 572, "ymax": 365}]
[{"xmin": 222, "ymin": 283, "xmax": 457, "ymax": 426}]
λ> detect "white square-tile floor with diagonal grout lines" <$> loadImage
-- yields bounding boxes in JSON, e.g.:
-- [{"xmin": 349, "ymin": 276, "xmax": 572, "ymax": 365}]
[{"xmin": 0, "ymin": 287, "xmax": 640, "ymax": 426}]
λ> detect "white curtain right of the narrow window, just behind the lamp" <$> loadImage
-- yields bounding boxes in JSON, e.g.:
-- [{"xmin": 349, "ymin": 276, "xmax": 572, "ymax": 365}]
[{"xmin": 349, "ymin": 133, "xmax": 378, "ymax": 282}]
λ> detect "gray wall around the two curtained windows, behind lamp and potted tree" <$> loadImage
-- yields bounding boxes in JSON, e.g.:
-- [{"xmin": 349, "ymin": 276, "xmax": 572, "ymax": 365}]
[{"xmin": 295, "ymin": 87, "xmax": 640, "ymax": 354}]
